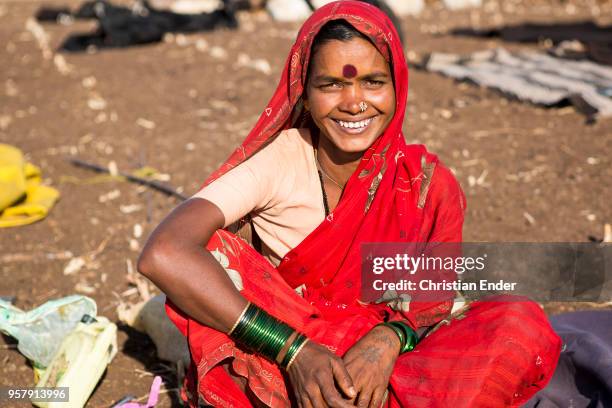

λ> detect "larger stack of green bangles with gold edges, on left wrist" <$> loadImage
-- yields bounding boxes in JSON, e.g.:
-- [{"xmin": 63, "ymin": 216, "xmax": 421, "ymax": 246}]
[{"xmin": 228, "ymin": 302, "xmax": 308, "ymax": 369}]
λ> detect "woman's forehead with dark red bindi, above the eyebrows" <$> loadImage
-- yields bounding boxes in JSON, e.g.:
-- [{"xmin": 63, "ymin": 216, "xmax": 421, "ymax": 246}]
[{"xmin": 311, "ymin": 38, "xmax": 389, "ymax": 78}]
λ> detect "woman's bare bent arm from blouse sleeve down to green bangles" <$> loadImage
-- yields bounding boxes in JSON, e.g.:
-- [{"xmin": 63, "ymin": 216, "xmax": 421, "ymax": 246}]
[{"xmin": 138, "ymin": 198, "xmax": 247, "ymax": 332}]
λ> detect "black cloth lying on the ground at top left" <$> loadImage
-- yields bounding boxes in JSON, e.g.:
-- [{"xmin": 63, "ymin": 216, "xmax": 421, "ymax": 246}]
[{"xmin": 37, "ymin": 0, "xmax": 238, "ymax": 52}]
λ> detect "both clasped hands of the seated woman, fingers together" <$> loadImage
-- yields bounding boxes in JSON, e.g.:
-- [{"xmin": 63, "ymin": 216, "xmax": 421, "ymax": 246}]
[{"xmin": 288, "ymin": 326, "xmax": 400, "ymax": 408}]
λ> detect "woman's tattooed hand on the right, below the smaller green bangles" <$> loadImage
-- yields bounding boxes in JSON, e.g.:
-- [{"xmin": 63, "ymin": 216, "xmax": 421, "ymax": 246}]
[{"xmin": 343, "ymin": 326, "xmax": 400, "ymax": 408}]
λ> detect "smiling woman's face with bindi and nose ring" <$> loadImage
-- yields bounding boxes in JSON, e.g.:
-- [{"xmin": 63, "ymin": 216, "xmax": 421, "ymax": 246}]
[{"xmin": 304, "ymin": 38, "xmax": 395, "ymax": 153}]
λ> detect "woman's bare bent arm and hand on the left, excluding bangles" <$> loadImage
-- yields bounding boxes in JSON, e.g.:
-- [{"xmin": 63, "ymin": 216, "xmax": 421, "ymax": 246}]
[{"xmin": 138, "ymin": 198, "xmax": 355, "ymax": 408}]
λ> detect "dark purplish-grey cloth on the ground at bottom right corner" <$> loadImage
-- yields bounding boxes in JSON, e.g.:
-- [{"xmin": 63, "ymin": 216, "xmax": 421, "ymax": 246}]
[{"xmin": 524, "ymin": 311, "xmax": 612, "ymax": 408}]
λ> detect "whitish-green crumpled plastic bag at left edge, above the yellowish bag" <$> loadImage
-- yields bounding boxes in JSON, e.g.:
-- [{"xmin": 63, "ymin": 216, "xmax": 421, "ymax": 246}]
[{"xmin": 0, "ymin": 295, "xmax": 97, "ymax": 368}]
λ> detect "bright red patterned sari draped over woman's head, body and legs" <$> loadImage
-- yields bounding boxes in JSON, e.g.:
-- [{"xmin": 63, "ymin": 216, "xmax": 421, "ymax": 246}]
[{"xmin": 167, "ymin": 1, "xmax": 560, "ymax": 407}]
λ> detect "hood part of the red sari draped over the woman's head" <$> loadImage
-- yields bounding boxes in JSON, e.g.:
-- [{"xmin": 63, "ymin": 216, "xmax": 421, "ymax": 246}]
[{"xmin": 205, "ymin": 1, "xmax": 408, "ymax": 185}]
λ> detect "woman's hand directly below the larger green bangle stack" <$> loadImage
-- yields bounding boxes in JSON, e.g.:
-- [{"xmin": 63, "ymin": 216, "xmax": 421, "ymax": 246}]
[{"xmin": 289, "ymin": 341, "xmax": 357, "ymax": 408}]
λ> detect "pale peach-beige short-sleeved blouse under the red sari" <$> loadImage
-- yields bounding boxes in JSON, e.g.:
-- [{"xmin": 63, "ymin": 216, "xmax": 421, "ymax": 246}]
[{"xmin": 192, "ymin": 129, "xmax": 325, "ymax": 265}]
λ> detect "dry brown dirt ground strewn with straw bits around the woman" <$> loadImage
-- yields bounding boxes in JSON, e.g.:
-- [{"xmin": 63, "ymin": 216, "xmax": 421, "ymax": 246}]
[{"xmin": 0, "ymin": 0, "xmax": 612, "ymax": 407}]
